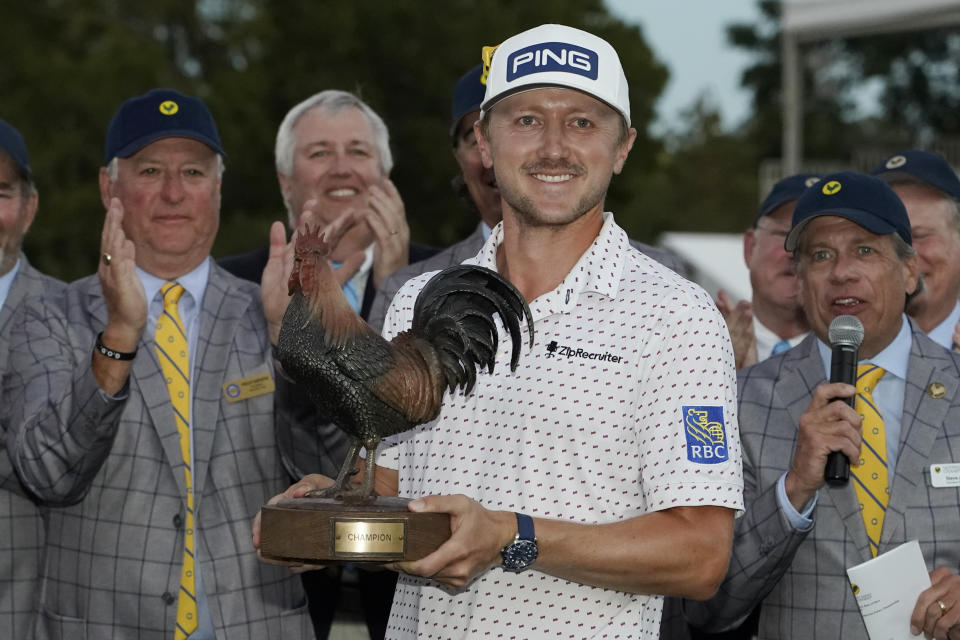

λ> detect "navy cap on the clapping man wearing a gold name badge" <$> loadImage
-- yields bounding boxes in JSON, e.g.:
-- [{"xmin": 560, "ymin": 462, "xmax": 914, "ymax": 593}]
[{"xmin": 103, "ymin": 89, "xmax": 226, "ymax": 164}]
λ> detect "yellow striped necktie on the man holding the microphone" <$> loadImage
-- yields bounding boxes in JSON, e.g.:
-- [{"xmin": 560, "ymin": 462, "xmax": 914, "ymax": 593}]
[{"xmin": 850, "ymin": 364, "xmax": 890, "ymax": 557}]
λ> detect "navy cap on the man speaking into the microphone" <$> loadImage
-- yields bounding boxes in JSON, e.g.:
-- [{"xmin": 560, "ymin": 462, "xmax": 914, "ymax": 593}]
[{"xmin": 783, "ymin": 171, "xmax": 913, "ymax": 251}]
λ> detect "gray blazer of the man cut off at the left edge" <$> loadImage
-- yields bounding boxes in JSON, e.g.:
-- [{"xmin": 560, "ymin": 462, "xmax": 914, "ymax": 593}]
[{"xmin": 0, "ymin": 253, "xmax": 64, "ymax": 638}]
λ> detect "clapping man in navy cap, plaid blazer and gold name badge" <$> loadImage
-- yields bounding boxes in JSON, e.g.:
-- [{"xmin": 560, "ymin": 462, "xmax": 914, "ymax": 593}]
[{"xmin": 0, "ymin": 89, "xmax": 324, "ymax": 640}]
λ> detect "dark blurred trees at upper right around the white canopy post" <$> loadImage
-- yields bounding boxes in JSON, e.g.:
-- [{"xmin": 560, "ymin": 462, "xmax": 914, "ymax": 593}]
[{"xmin": 727, "ymin": 0, "xmax": 960, "ymax": 160}]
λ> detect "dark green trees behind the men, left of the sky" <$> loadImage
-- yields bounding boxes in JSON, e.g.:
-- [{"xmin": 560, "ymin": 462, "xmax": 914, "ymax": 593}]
[{"xmin": 0, "ymin": 0, "xmax": 667, "ymax": 280}]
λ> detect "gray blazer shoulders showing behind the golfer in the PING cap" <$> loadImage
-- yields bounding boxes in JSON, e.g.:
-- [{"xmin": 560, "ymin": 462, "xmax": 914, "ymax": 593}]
[{"xmin": 367, "ymin": 222, "xmax": 687, "ymax": 333}]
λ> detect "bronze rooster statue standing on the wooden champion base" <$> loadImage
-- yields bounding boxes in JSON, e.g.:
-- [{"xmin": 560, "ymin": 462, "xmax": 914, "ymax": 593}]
[{"xmin": 277, "ymin": 228, "xmax": 533, "ymax": 503}]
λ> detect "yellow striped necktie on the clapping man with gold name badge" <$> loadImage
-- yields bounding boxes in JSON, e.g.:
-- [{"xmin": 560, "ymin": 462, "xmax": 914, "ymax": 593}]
[{"xmin": 155, "ymin": 282, "xmax": 197, "ymax": 640}]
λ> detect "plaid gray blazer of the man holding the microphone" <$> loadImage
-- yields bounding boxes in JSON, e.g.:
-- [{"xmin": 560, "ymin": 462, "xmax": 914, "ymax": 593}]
[{"xmin": 684, "ymin": 323, "xmax": 960, "ymax": 640}]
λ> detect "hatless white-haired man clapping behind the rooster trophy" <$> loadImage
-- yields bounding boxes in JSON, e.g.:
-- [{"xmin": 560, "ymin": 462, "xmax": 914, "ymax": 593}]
[{"xmin": 220, "ymin": 89, "xmax": 435, "ymax": 318}]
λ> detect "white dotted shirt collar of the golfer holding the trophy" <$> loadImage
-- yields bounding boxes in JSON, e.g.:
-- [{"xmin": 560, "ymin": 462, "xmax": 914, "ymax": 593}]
[{"xmin": 468, "ymin": 211, "xmax": 629, "ymax": 307}]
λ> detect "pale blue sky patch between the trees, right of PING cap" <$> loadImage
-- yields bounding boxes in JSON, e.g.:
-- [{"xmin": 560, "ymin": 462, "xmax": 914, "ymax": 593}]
[{"xmin": 606, "ymin": 0, "xmax": 759, "ymax": 133}]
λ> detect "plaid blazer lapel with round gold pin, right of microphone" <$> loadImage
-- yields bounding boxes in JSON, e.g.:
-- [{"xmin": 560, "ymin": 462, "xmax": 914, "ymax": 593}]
[{"xmin": 880, "ymin": 329, "xmax": 960, "ymax": 552}]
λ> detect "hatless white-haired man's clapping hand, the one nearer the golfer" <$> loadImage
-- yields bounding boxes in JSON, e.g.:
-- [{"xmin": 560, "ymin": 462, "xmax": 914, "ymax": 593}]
[{"xmin": 367, "ymin": 178, "xmax": 410, "ymax": 289}]
